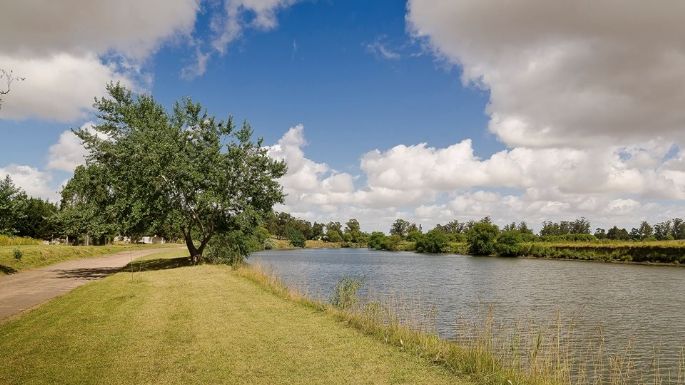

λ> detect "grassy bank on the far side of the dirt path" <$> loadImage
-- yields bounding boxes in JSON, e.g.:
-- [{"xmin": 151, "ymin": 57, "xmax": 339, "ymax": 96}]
[{"xmin": 0, "ymin": 244, "xmax": 178, "ymax": 275}]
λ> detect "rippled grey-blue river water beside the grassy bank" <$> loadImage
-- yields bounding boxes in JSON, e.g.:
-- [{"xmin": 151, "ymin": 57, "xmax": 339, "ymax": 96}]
[{"xmin": 249, "ymin": 249, "xmax": 685, "ymax": 378}]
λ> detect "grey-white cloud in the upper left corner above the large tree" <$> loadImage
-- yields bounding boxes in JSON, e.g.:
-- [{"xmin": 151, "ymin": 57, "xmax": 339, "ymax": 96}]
[{"xmin": 0, "ymin": 0, "xmax": 294, "ymax": 118}]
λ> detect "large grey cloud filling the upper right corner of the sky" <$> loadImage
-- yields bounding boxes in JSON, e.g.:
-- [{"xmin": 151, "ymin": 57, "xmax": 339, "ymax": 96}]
[{"xmin": 407, "ymin": 0, "xmax": 685, "ymax": 147}]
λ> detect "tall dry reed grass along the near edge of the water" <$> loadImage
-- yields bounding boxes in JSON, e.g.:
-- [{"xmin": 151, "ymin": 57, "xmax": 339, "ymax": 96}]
[{"xmin": 236, "ymin": 265, "xmax": 685, "ymax": 385}]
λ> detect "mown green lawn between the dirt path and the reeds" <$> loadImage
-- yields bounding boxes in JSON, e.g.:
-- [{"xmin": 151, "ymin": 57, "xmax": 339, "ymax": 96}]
[{"xmin": 0, "ymin": 251, "xmax": 464, "ymax": 384}]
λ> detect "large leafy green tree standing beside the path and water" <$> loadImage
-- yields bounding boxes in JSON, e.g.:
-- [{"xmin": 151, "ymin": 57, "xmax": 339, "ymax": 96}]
[{"xmin": 65, "ymin": 84, "xmax": 286, "ymax": 263}]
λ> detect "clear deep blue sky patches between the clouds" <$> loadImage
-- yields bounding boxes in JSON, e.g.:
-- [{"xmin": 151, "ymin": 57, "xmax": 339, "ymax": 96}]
[{"xmin": 0, "ymin": 1, "xmax": 492, "ymax": 170}]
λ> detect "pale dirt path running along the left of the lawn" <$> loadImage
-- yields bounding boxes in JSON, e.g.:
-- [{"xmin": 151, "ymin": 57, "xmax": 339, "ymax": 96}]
[{"xmin": 0, "ymin": 248, "xmax": 182, "ymax": 320}]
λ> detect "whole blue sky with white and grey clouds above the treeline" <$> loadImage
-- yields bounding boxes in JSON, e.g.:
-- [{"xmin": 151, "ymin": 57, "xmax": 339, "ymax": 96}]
[{"xmin": 0, "ymin": 0, "xmax": 685, "ymax": 230}]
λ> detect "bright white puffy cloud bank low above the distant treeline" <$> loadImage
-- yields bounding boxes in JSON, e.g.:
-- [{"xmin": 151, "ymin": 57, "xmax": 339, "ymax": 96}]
[{"xmin": 269, "ymin": 125, "xmax": 685, "ymax": 230}]
